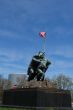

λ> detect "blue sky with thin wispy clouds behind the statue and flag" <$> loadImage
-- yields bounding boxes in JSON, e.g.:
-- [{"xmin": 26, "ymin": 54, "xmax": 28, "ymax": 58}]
[{"xmin": 0, "ymin": 0, "xmax": 73, "ymax": 78}]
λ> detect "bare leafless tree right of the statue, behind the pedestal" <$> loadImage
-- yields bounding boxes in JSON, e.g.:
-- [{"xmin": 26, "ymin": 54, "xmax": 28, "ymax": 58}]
[{"xmin": 52, "ymin": 74, "xmax": 73, "ymax": 90}]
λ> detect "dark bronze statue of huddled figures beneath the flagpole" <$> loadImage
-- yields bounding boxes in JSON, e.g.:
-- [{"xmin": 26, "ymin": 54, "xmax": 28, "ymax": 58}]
[{"xmin": 27, "ymin": 52, "xmax": 51, "ymax": 81}]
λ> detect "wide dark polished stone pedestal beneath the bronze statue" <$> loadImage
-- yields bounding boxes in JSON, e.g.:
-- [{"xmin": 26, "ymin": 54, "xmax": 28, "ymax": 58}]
[{"xmin": 3, "ymin": 88, "xmax": 71, "ymax": 107}]
